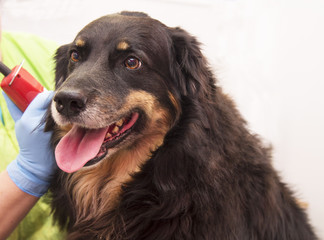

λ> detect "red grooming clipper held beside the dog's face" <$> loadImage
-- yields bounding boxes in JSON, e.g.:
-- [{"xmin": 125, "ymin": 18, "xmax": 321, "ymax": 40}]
[{"xmin": 0, "ymin": 61, "xmax": 44, "ymax": 112}]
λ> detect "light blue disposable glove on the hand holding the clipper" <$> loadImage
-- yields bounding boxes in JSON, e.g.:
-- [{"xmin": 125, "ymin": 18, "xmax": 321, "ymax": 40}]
[{"xmin": 4, "ymin": 90, "xmax": 57, "ymax": 197}]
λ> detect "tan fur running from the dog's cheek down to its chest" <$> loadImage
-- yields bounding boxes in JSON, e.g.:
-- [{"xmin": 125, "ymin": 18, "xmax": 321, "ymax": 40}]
[{"xmin": 60, "ymin": 91, "xmax": 171, "ymax": 223}]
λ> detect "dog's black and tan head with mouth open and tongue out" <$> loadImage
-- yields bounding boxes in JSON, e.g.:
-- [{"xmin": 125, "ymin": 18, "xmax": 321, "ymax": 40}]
[{"xmin": 48, "ymin": 12, "xmax": 208, "ymax": 172}]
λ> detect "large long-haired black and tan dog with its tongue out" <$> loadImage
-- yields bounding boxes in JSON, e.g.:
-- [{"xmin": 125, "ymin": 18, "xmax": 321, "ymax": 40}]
[{"xmin": 46, "ymin": 12, "xmax": 317, "ymax": 240}]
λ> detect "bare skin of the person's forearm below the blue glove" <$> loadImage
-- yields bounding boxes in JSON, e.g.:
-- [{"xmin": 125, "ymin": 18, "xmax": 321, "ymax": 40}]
[{"xmin": 0, "ymin": 171, "xmax": 39, "ymax": 239}]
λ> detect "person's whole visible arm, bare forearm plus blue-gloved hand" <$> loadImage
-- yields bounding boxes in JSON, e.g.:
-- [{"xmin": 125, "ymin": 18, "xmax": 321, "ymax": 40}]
[{"xmin": 0, "ymin": 91, "xmax": 57, "ymax": 240}]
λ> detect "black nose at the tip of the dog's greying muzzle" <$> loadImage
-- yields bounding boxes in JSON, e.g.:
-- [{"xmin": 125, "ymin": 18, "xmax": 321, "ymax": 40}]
[{"xmin": 54, "ymin": 90, "xmax": 87, "ymax": 116}]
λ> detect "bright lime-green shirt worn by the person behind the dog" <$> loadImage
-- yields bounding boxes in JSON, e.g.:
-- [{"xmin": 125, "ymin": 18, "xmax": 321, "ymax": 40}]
[{"xmin": 0, "ymin": 32, "xmax": 64, "ymax": 240}]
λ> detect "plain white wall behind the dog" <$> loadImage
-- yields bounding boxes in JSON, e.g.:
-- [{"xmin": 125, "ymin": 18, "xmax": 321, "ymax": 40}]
[{"xmin": 2, "ymin": 0, "xmax": 324, "ymax": 236}]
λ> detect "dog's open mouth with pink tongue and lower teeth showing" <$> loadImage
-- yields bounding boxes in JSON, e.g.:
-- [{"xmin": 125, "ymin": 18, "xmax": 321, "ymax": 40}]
[{"xmin": 55, "ymin": 112, "xmax": 139, "ymax": 173}]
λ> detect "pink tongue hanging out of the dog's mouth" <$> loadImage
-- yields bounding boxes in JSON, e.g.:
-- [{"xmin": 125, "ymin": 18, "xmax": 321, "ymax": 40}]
[{"xmin": 55, "ymin": 126, "xmax": 108, "ymax": 173}]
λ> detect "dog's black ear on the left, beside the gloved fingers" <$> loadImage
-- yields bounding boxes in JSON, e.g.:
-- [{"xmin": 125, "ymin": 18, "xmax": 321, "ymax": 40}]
[{"xmin": 55, "ymin": 44, "xmax": 70, "ymax": 89}]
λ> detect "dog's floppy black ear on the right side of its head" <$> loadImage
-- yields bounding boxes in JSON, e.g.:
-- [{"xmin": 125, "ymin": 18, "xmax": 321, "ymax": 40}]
[{"xmin": 170, "ymin": 28, "xmax": 212, "ymax": 97}]
